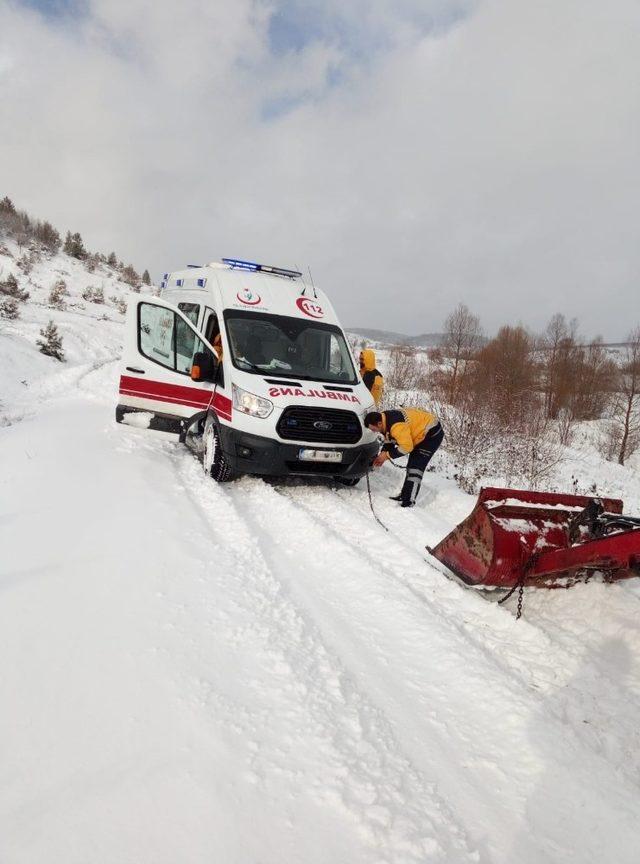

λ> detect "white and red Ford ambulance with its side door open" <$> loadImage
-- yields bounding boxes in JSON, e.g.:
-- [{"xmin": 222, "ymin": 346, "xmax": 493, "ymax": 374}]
[{"xmin": 116, "ymin": 258, "xmax": 378, "ymax": 484}]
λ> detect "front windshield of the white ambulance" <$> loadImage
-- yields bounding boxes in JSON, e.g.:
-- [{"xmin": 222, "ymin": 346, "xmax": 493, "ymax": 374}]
[{"xmin": 224, "ymin": 310, "xmax": 358, "ymax": 384}]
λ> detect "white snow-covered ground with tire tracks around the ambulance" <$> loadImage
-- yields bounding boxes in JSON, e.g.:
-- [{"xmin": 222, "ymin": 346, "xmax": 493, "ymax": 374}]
[{"xmin": 0, "ymin": 250, "xmax": 640, "ymax": 864}]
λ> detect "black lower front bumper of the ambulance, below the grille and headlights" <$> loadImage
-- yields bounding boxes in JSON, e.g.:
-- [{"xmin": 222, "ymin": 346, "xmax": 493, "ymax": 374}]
[{"xmin": 218, "ymin": 424, "xmax": 379, "ymax": 479}]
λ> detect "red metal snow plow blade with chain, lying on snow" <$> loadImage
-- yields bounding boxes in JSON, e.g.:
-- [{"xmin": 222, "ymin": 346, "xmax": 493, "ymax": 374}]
[{"xmin": 427, "ymin": 488, "xmax": 640, "ymax": 588}]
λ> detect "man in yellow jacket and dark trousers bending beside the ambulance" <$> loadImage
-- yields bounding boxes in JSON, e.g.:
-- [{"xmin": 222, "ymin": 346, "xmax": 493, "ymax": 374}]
[{"xmin": 364, "ymin": 408, "xmax": 444, "ymax": 507}]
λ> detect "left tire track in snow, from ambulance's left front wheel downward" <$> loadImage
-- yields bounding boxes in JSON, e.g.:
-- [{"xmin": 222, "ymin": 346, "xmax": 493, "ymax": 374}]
[{"xmin": 171, "ymin": 457, "xmax": 480, "ymax": 864}]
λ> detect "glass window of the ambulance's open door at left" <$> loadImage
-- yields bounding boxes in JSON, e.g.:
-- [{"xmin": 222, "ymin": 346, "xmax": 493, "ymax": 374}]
[{"xmin": 138, "ymin": 303, "xmax": 205, "ymax": 375}]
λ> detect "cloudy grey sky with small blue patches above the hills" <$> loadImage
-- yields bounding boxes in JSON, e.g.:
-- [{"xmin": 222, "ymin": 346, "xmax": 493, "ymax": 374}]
[{"xmin": 0, "ymin": 0, "xmax": 640, "ymax": 339}]
